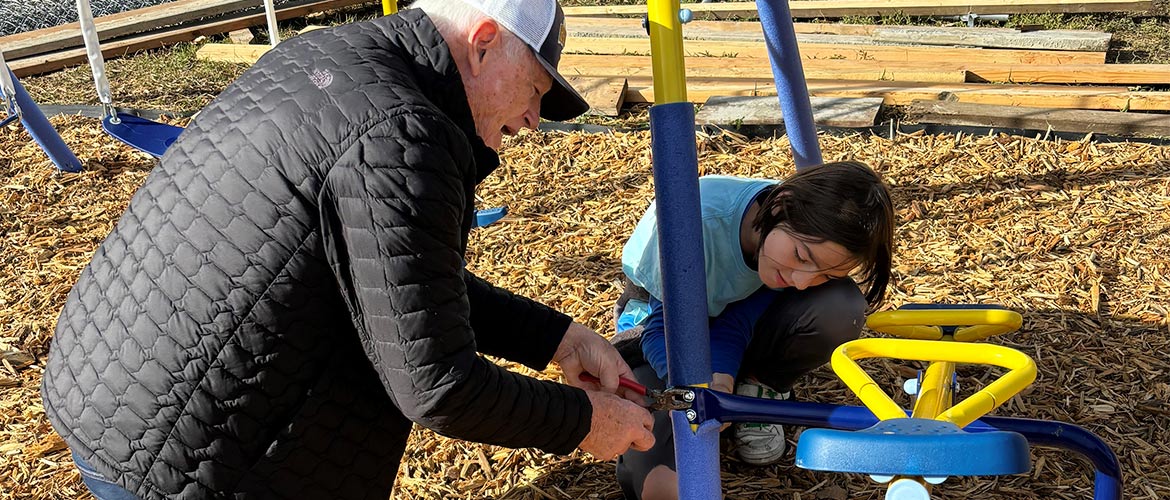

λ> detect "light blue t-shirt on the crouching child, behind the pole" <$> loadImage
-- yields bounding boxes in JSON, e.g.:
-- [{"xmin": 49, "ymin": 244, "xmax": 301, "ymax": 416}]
[{"xmin": 621, "ymin": 176, "xmax": 778, "ymax": 317}]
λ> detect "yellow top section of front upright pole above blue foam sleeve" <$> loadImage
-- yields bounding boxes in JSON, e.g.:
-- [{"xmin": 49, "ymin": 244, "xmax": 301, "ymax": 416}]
[{"xmin": 646, "ymin": 0, "xmax": 687, "ymax": 104}]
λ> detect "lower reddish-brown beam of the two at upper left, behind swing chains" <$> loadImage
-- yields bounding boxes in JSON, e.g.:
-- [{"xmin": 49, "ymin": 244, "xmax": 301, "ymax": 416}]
[{"xmin": 8, "ymin": 0, "xmax": 367, "ymax": 76}]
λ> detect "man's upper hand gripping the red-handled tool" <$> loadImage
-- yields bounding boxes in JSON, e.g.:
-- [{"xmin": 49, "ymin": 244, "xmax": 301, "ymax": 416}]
[{"xmin": 552, "ymin": 322, "xmax": 645, "ymax": 402}]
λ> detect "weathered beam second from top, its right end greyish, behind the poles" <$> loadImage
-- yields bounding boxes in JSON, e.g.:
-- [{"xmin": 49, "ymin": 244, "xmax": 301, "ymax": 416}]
[{"xmin": 565, "ymin": 18, "xmax": 1113, "ymax": 52}]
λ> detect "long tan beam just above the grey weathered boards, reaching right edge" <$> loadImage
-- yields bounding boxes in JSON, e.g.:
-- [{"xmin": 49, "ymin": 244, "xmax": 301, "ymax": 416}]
[{"xmin": 626, "ymin": 77, "xmax": 1170, "ymax": 111}]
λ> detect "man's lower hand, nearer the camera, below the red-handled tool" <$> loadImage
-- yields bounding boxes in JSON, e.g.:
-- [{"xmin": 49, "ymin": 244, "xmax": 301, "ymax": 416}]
[{"xmin": 578, "ymin": 390, "xmax": 654, "ymax": 461}]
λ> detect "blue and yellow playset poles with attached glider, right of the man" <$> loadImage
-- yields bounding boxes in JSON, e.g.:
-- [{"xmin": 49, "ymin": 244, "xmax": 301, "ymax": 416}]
[{"xmin": 647, "ymin": 0, "xmax": 1121, "ymax": 500}]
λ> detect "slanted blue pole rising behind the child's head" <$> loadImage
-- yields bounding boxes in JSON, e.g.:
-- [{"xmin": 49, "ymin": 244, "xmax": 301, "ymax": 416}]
[{"xmin": 756, "ymin": 0, "xmax": 823, "ymax": 170}]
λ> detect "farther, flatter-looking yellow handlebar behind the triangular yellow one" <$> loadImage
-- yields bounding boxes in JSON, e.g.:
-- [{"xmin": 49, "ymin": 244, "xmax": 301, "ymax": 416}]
[{"xmin": 866, "ymin": 309, "xmax": 1024, "ymax": 342}]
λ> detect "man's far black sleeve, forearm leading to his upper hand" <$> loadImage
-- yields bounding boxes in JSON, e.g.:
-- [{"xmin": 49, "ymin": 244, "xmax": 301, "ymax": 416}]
[{"xmin": 464, "ymin": 272, "xmax": 572, "ymax": 370}]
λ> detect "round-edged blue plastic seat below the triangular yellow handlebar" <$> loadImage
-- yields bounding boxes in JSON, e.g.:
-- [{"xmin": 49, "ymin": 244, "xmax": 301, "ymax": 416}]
[{"xmin": 796, "ymin": 418, "xmax": 1032, "ymax": 477}]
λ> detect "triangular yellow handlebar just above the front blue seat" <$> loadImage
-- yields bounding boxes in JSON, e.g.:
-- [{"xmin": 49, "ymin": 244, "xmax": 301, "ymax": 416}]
[{"xmin": 832, "ymin": 338, "xmax": 1035, "ymax": 427}]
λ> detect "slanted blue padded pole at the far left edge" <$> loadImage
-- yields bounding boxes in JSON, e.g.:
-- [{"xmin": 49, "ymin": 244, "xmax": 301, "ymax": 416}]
[{"xmin": 0, "ymin": 50, "xmax": 81, "ymax": 172}]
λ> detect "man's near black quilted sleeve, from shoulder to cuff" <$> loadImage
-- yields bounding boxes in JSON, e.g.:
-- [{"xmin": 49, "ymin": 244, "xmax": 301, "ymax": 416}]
[{"xmin": 319, "ymin": 109, "xmax": 592, "ymax": 453}]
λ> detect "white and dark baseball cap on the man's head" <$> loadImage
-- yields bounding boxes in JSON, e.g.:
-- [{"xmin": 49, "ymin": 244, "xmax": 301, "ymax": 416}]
[{"xmin": 462, "ymin": 0, "xmax": 589, "ymax": 121}]
